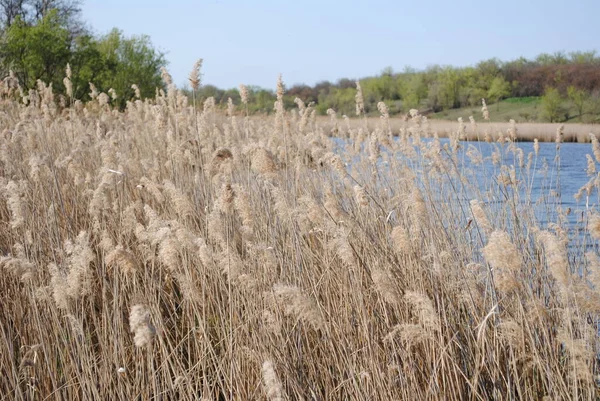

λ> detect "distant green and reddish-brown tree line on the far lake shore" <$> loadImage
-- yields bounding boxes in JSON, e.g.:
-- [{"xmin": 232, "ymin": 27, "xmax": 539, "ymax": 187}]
[{"xmin": 189, "ymin": 51, "xmax": 600, "ymax": 121}]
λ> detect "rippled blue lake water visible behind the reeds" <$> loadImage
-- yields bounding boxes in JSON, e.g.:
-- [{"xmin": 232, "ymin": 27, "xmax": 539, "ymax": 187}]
[{"xmin": 335, "ymin": 139, "xmax": 600, "ymax": 247}]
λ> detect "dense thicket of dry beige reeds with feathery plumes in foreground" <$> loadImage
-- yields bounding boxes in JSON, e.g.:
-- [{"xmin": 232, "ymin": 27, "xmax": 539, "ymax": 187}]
[{"xmin": 0, "ymin": 67, "xmax": 600, "ymax": 400}]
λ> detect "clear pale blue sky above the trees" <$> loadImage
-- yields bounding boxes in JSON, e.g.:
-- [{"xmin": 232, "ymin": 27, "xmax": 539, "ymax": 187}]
[{"xmin": 83, "ymin": 0, "xmax": 600, "ymax": 88}]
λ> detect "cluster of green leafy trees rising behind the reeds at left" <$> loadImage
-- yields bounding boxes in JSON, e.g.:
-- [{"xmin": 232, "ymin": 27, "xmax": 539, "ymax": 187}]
[{"xmin": 0, "ymin": 0, "xmax": 166, "ymax": 108}]
